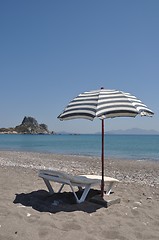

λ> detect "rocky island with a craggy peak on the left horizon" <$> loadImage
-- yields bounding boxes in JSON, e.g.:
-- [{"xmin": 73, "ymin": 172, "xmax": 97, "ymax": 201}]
[{"xmin": 0, "ymin": 116, "xmax": 54, "ymax": 134}]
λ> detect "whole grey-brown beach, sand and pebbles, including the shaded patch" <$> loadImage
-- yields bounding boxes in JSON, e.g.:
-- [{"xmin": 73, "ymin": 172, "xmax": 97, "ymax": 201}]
[{"xmin": 0, "ymin": 151, "xmax": 159, "ymax": 240}]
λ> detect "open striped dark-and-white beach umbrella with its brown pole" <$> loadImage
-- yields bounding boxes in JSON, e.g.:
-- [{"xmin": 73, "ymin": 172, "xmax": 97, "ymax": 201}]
[{"xmin": 58, "ymin": 88, "xmax": 154, "ymax": 197}]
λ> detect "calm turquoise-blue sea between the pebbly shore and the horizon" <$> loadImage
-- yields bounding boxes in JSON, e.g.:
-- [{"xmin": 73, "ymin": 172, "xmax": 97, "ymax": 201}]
[{"xmin": 0, "ymin": 134, "xmax": 159, "ymax": 161}]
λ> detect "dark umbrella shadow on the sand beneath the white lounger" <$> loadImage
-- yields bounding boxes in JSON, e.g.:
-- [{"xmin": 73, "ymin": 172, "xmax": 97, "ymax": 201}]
[{"xmin": 13, "ymin": 189, "xmax": 103, "ymax": 213}]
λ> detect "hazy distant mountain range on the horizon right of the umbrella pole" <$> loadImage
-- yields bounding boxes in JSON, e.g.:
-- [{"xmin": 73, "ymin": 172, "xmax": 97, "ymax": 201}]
[{"xmin": 106, "ymin": 128, "xmax": 159, "ymax": 135}]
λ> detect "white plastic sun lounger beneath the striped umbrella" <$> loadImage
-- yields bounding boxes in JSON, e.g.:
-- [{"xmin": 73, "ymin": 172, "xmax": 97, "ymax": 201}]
[{"xmin": 39, "ymin": 170, "xmax": 118, "ymax": 203}]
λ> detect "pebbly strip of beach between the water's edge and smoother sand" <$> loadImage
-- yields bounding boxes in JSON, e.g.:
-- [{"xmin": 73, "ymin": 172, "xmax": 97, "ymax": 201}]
[{"xmin": 0, "ymin": 151, "xmax": 159, "ymax": 185}]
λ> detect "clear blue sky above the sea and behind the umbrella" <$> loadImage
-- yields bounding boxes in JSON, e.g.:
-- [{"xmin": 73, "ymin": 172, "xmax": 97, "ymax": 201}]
[{"xmin": 0, "ymin": 0, "xmax": 159, "ymax": 133}]
